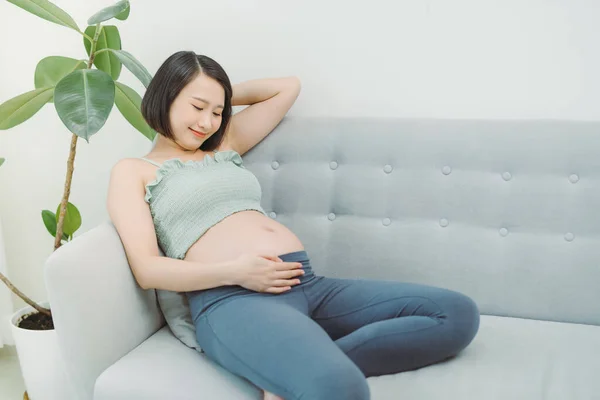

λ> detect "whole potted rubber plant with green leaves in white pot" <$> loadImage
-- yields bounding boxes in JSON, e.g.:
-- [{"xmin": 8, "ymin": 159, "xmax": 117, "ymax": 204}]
[{"xmin": 0, "ymin": 0, "xmax": 156, "ymax": 400}]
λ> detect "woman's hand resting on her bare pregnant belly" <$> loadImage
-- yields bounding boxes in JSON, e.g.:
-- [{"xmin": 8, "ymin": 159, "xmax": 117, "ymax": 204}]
[{"xmin": 232, "ymin": 253, "xmax": 304, "ymax": 294}]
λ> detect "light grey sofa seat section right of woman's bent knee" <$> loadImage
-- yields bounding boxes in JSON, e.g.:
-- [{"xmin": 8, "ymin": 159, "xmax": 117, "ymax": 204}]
[{"xmin": 369, "ymin": 315, "xmax": 600, "ymax": 400}]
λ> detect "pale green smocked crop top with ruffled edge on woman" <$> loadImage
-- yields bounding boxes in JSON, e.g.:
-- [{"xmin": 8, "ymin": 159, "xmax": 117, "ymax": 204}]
[{"xmin": 142, "ymin": 150, "xmax": 266, "ymax": 259}]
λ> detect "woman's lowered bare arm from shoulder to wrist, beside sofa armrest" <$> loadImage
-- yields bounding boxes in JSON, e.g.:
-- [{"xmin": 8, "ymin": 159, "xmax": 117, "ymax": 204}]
[{"xmin": 107, "ymin": 159, "xmax": 235, "ymax": 292}]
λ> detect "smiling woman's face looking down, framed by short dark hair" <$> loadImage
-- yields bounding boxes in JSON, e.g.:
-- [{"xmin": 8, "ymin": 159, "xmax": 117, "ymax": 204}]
[{"xmin": 169, "ymin": 74, "xmax": 225, "ymax": 150}]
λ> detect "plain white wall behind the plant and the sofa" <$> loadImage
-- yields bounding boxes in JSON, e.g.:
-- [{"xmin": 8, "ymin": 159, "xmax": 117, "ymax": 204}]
[{"xmin": 0, "ymin": 0, "xmax": 600, "ymax": 324}]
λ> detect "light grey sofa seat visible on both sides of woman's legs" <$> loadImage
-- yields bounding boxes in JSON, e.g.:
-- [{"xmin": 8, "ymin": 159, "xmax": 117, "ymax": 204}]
[{"xmin": 94, "ymin": 315, "xmax": 600, "ymax": 400}]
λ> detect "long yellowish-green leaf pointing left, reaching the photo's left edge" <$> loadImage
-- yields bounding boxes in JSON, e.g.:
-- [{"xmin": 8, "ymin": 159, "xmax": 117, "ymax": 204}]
[{"xmin": 0, "ymin": 88, "xmax": 54, "ymax": 129}]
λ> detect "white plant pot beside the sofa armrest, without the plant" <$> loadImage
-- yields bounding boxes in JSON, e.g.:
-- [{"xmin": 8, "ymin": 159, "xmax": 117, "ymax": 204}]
[{"xmin": 10, "ymin": 302, "xmax": 75, "ymax": 400}]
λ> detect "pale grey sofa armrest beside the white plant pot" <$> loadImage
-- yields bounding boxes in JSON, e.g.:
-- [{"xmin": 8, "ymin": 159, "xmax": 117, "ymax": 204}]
[{"xmin": 44, "ymin": 222, "xmax": 165, "ymax": 400}]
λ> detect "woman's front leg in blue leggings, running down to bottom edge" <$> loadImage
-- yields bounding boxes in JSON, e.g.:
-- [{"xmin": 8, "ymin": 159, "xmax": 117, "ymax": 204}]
[{"xmin": 195, "ymin": 287, "xmax": 370, "ymax": 400}]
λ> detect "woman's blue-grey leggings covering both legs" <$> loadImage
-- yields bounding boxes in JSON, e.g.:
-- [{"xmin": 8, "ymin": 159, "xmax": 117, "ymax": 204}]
[{"xmin": 187, "ymin": 251, "xmax": 479, "ymax": 400}]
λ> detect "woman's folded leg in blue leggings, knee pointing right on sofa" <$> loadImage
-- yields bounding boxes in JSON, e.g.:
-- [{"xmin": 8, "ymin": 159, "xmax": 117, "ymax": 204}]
[{"xmin": 303, "ymin": 278, "xmax": 479, "ymax": 377}]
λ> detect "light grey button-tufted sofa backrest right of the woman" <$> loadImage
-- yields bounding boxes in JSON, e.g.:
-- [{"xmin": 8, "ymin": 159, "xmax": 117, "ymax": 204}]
[{"xmin": 244, "ymin": 117, "xmax": 600, "ymax": 325}]
